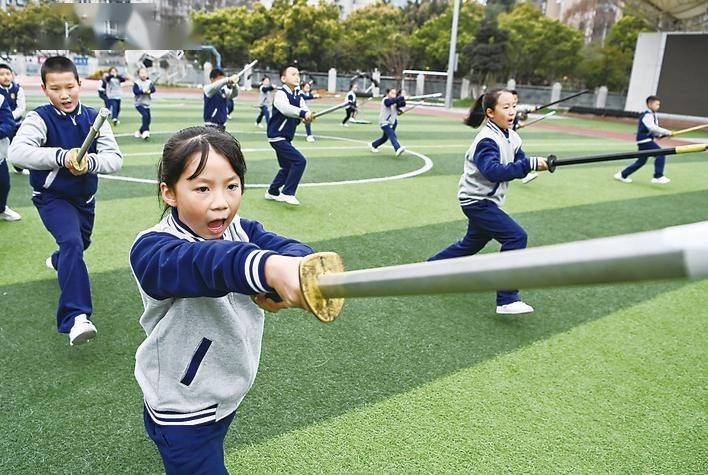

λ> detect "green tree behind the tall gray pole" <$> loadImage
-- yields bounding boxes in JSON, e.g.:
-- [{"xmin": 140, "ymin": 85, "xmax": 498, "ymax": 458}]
[{"xmin": 411, "ymin": 0, "xmax": 484, "ymax": 72}]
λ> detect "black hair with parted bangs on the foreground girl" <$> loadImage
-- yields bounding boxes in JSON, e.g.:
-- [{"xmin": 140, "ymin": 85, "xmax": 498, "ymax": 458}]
[{"xmin": 157, "ymin": 125, "xmax": 246, "ymax": 214}]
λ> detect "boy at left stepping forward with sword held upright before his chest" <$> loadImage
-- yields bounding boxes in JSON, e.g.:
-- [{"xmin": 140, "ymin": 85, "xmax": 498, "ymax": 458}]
[{"xmin": 9, "ymin": 56, "xmax": 123, "ymax": 346}]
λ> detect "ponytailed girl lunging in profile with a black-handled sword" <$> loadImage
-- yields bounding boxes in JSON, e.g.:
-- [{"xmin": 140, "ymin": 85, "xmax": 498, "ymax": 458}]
[{"xmin": 429, "ymin": 89, "xmax": 548, "ymax": 314}]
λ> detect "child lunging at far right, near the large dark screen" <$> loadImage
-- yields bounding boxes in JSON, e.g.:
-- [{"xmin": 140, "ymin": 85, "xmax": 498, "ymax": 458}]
[{"xmin": 614, "ymin": 96, "xmax": 673, "ymax": 185}]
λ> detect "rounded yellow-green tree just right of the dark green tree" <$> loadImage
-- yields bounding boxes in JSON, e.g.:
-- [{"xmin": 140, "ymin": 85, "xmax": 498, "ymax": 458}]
[{"xmin": 499, "ymin": 3, "xmax": 583, "ymax": 83}]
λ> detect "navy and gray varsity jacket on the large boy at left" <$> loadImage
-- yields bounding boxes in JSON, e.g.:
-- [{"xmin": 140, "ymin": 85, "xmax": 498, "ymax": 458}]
[{"xmin": 8, "ymin": 104, "xmax": 123, "ymax": 202}]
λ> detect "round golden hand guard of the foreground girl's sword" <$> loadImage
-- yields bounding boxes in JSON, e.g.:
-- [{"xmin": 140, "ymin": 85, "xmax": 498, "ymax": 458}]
[{"xmin": 300, "ymin": 252, "xmax": 344, "ymax": 323}]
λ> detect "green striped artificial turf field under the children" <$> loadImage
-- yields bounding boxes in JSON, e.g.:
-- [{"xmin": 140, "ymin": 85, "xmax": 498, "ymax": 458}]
[{"xmin": 0, "ymin": 96, "xmax": 708, "ymax": 474}]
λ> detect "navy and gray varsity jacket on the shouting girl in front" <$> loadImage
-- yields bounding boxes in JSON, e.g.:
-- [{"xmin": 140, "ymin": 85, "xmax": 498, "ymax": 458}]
[{"xmin": 130, "ymin": 210, "xmax": 313, "ymax": 425}]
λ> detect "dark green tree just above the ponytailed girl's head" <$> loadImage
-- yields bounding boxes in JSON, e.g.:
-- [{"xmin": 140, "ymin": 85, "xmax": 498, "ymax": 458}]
[{"xmin": 462, "ymin": 18, "xmax": 509, "ymax": 84}]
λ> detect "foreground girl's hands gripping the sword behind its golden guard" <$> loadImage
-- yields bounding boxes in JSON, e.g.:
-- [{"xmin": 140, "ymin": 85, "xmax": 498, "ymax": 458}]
[{"xmin": 254, "ymin": 255, "xmax": 305, "ymax": 312}]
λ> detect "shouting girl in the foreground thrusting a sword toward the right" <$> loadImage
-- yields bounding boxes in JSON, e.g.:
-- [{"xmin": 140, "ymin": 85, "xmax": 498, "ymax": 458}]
[{"xmin": 130, "ymin": 124, "xmax": 313, "ymax": 474}]
